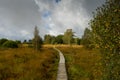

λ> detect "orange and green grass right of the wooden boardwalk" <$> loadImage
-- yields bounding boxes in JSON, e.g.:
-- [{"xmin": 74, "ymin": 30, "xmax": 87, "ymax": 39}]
[{"xmin": 58, "ymin": 47, "xmax": 102, "ymax": 80}]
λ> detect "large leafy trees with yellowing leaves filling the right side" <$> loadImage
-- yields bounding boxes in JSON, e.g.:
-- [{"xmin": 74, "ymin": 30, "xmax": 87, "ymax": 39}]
[{"xmin": 82, "ymin": 0, "xmax": 120, "ymax": 80}]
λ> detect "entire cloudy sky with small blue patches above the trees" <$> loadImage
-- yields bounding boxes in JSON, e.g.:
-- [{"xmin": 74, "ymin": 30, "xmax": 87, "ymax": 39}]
[{"xmin": 0, "ymin": 0, "xmax": 105, "ymax": 40}]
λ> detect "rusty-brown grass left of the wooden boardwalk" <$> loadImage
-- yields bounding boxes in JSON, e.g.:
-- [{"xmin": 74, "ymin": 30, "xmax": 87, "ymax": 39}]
[{"xmin": 0, "ymin": 48, "xmax": 59, "ymax": 80}]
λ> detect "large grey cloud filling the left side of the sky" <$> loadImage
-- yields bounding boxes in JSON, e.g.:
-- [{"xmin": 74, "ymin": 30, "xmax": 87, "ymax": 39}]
[{"xmin": 0, "ymin": 0, "xmax": 44, "ymax": 40}]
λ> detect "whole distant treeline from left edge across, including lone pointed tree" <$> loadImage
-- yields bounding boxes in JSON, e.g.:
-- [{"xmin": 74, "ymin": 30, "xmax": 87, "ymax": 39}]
[{"xmin": 0, "ymin": 26, "xmax": 81, "ymax": 49}]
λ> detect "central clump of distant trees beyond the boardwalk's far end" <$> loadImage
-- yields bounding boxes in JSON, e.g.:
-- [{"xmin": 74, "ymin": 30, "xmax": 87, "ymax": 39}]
[{"xmin": 43, "ymin": 29, "xmax": 81, "ymax": 45}]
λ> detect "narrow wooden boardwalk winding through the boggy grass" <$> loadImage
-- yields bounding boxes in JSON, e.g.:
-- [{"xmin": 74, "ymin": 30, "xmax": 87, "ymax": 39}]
[{"xmin": 54, "ymin": 48, "xmax": 67, "ymax": 80}]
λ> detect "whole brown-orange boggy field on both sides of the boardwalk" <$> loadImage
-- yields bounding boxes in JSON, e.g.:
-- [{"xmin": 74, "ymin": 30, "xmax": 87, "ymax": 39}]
[{"xmin": 0, "ymin": 46, "xmax": 103, "ymax": 80}]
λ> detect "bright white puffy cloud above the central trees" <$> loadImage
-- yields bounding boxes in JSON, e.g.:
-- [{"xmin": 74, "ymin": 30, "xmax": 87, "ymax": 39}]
[{"xmin": 35, "ymin": 0, "xmax": 89, "ymax": 36}]
